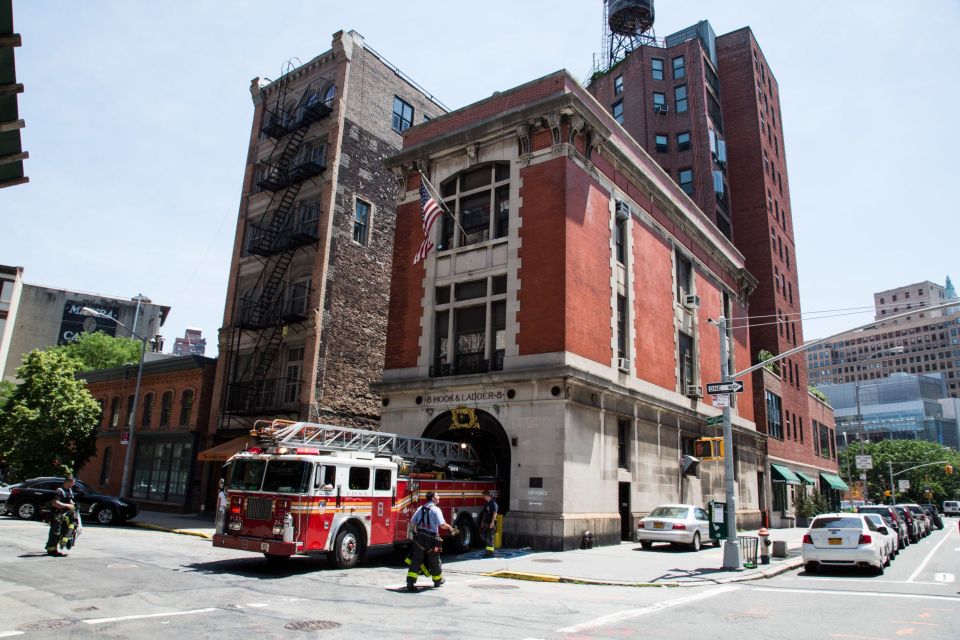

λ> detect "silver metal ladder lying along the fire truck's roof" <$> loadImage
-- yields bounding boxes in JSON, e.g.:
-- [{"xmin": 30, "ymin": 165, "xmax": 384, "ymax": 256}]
[{"xmin": 257, "ymin": 421, "xmax": 480, "ymax": 467}]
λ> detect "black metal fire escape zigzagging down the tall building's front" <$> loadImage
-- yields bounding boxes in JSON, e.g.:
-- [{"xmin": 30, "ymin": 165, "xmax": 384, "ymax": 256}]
[{"xmin": 222, "ymin": 76, "xmax": 335, "ymax": 426}]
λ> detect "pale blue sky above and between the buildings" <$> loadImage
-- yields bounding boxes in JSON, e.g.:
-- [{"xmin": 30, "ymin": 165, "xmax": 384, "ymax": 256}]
[{"xmin": 0, "ymin": 0, "xmax": 960, "ymax": 355}]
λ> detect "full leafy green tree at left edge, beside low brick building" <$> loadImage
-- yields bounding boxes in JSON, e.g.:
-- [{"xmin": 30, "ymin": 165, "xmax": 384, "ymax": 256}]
[{"xmin": 0, "ymin": 349, "xmax": 100, "ymax": 479}]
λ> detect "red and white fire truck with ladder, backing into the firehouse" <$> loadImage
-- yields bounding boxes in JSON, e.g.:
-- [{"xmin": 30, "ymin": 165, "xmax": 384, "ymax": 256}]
[{"xmin": 213, "ymin": 420, "xmax": 497, "ymax": 569}]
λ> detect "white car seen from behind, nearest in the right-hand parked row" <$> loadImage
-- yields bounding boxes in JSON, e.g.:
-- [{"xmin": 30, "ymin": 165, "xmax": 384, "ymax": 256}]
[{"xmin": 801, "ymin": 513, "xmax": 889, "ymax": 575}]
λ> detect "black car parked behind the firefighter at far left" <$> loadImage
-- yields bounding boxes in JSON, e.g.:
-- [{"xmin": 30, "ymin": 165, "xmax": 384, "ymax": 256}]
[{"xmin": 7, "ymin": 478, "xmax": 139, "ymax": 524}]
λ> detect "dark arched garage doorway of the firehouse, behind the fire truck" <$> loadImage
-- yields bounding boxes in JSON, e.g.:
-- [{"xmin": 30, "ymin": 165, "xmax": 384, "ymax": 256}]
[{"xmin": 423, "ymin": 407, "xmax": 510, "ymax": 513}]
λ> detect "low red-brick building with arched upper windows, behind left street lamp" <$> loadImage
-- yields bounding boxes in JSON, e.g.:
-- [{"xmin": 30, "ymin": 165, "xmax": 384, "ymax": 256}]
[{"xmin": 78, "ymin": 356, "xmax": 219, "ymax": 513}]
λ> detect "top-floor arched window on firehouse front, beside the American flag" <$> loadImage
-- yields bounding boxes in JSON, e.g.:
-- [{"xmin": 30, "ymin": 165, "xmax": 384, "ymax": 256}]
[{"xmin": 437, "ymin": 163, "xmax": 510, "ymax": 251}]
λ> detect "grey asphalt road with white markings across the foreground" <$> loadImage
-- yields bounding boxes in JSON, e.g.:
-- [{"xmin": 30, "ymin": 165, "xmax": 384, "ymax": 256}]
[{"xmin": 0, "ymin": 518, "xmax": 960, "ymax": 640}]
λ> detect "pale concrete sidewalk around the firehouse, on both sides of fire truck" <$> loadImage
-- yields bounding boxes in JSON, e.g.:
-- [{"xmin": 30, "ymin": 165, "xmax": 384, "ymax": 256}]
[{"xmin": 130, "ymin": 511, "xmax": 807, "ymax": 587}]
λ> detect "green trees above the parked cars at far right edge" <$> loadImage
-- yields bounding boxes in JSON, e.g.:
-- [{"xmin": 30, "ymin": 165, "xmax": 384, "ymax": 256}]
[{"xmin": 838, "ymin": 440, "xmax": 960, "ymax": 504}]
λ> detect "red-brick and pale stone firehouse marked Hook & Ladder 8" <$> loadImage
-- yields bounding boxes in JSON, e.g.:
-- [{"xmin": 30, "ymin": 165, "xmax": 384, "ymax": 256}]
[{"xmin": 374, "ymin": 71, "xmax": 766, "ymax": 550}]
